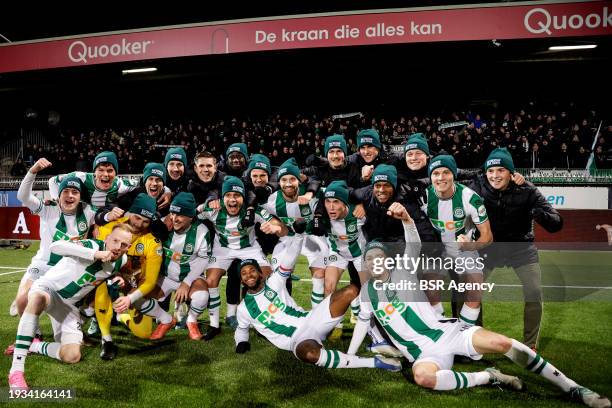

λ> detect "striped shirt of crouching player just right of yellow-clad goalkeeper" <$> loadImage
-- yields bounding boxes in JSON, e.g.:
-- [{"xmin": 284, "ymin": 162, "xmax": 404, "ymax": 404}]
[{"xmin": 161, "ymin": 220, "xmax": 212, "ymax": 286}]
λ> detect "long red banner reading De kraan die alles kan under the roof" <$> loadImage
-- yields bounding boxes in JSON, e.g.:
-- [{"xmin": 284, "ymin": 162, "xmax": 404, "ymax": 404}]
[{"xmin": 0, "ymin": 1, "xmax": 612, "ymax": 73}]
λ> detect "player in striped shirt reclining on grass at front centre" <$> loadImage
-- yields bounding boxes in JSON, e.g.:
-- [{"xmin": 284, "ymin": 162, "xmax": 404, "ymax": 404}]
[{"xmin": 234, "ymin": 235, "xmax": 401, "ymax": 371}]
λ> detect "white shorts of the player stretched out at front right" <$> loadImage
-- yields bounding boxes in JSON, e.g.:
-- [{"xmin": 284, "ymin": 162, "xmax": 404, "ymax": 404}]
[{"xmin": 413, "ymin": 321, "xmax": 482, "ymax": 370}]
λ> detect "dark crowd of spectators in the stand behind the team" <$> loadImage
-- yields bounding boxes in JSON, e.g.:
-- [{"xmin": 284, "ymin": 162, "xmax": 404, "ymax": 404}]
[{"xmin": 11, "ymin": 105, "xmax": 612, "ymax": 176}]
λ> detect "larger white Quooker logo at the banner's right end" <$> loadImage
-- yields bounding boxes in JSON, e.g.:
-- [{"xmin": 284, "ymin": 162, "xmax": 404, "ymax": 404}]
[{"xmin": 524, "ymin": 7, "xmax": 612, "ymax": 35}]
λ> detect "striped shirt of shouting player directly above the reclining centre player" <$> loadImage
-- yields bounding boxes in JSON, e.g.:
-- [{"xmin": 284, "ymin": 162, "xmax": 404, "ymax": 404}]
[{"xmin": 198, "ymin": 207, "xmax": 272, "ymax": 249}]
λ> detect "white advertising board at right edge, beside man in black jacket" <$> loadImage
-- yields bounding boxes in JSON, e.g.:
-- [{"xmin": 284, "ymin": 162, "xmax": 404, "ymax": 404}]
[{"xmin": 538, "ymin": 186, "xmax": 608, "ymax": 210}]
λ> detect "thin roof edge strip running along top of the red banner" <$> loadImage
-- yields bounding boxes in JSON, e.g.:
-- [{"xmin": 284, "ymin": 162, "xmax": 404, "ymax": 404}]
[{"xmin": 0, "ymin": 0, "xmax": 593, "ymax": 47}]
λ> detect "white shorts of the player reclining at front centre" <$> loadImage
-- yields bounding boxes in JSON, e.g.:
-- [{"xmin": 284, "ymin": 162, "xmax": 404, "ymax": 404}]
[{"xmin": 291, "ymin": 295, "xmax": 344, "ymax": 357}]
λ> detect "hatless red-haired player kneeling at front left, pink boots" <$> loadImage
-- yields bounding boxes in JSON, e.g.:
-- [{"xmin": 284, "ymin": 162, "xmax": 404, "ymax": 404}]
[{"xmin": 8, "ymin": 224, "xmax": 132, "ymax": 389}]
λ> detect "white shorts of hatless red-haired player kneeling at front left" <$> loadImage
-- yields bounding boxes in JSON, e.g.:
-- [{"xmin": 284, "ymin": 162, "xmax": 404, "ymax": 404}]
[{"xmin": 30, "ymin": 279, "xmax": 83, "ymax": 345}]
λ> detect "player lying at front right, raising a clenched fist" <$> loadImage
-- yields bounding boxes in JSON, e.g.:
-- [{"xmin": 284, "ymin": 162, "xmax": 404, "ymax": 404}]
[{"xmin": 348, "ymin": 203, "xmax": 610, "ymax": 407}]
